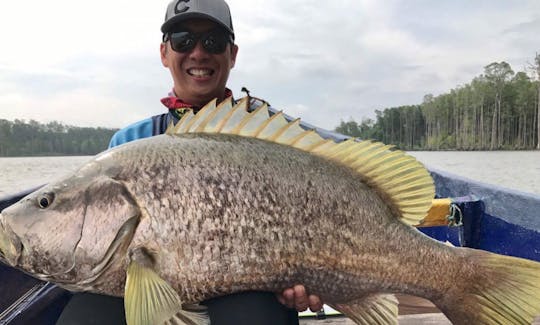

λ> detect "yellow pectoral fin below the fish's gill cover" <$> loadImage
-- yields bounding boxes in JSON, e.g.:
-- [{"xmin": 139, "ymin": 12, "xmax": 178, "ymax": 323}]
[{"xmin": 124, "ymin": 261, "xmax": 210, "ymax": 325}]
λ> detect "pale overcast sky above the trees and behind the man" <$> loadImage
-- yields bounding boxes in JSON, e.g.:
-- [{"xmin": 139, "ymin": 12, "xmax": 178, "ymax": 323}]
[{"xmin": 0, "ymin": 0, "xmax": 540, "ymax": 129}]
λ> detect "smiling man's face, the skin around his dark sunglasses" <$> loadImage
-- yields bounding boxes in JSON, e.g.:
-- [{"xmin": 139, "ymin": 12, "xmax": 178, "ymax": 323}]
[{"xmin": 160, "ymin": 19, "xmax": 238, "ymax": 106}]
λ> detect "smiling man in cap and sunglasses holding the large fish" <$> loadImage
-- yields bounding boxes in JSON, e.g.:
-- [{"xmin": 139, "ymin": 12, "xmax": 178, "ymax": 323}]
[{"xmin": 58, "ymin": 0, "xmax": 322, "ymax": 325}]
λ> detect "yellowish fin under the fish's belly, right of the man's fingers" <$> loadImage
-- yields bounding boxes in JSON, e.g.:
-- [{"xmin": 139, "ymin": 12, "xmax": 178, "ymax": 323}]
[{"xmin": 330, "ymin": 293, "xmax": 398, "ymax": 325}]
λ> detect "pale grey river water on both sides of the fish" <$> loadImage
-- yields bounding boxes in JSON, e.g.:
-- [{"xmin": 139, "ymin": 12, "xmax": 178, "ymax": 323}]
[{"xmin": 0, "ymin": 151, "xmax": 540, "ymax": 197}]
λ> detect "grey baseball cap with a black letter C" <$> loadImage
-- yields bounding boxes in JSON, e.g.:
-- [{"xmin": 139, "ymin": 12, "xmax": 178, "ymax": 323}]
[{"xmin": 161, "ymin": 0, "xmax": 234, "ymax": 38}]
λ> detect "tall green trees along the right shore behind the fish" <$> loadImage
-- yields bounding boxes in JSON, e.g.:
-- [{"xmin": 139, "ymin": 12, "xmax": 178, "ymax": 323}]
[{"xmin": 335, "ymin": 54, "xmax": 540, "ymax": 150}]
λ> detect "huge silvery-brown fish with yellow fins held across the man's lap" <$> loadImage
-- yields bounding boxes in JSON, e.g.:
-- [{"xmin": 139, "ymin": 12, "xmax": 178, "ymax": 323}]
[{"xmin": 0, "ymin": 100, "xmax": 540, "ymax": 324}]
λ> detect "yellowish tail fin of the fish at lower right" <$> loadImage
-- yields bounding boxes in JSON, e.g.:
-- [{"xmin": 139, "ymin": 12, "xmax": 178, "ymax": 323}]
[{"xmin": 433, "ymin": 249, "xmax": 540, "ymax": 325}]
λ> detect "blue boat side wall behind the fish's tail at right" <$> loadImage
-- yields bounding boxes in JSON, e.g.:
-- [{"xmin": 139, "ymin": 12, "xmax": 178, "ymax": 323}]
[{"xmin": 426, "ymin": 170, "xmax": 540, "ymax": 261}]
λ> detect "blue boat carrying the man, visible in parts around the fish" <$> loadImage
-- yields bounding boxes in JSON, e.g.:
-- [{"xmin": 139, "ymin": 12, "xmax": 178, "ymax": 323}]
[{"xmin": 0, "ymin": 111, "xmax": 540, "ymax": 325}]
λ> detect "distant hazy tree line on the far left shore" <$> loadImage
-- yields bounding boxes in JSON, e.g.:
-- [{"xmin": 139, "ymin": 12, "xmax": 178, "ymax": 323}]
[{"xmin": 0, "ymin": 119, "xmax": 117, "ymax": 157}]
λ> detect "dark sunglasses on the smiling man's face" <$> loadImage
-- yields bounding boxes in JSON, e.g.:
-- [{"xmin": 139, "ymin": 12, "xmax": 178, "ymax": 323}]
[{"xmin": 163, "ymin": 28, "xmax": 233, "ymax": 54}]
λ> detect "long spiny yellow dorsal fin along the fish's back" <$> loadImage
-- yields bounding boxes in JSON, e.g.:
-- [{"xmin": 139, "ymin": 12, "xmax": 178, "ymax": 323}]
[{"xmin": 167, "ymin": 98, "xmax": 435, "ymax": 225}]
